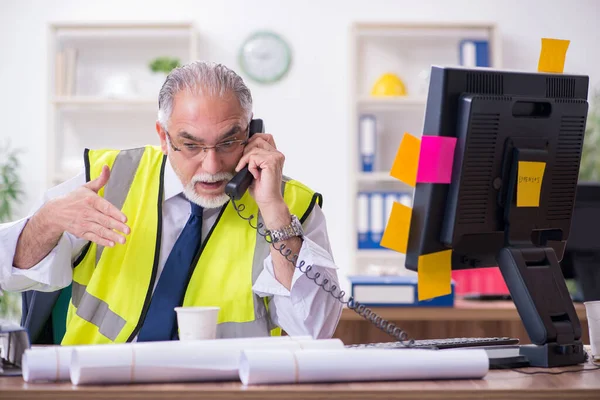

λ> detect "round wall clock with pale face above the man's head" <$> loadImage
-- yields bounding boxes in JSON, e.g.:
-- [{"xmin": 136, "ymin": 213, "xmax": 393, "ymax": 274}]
[{"xmin": 240, "ymin": 32, "xmax": 292, "ymax": 83}]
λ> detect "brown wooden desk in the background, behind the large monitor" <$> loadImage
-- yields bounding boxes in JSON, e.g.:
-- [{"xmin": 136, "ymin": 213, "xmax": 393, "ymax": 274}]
[{"xmin": 334, "ymin": 299, "xmax": 588, "ymax": 346}]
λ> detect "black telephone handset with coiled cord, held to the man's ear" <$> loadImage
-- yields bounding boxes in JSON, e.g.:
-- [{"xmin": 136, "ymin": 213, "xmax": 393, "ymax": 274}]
[{"xmin": 225, "ymin": 119, "xmax": 414, "ymax": 347}]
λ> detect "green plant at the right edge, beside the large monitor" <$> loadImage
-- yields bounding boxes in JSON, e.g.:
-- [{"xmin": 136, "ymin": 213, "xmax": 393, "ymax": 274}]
[{"xmin": 579, "ymin": 88, "xmax": 600, "ymax": 182}]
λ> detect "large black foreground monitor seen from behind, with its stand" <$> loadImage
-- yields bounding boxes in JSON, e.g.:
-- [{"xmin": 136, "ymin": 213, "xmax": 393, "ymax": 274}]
[{"xmin": 406, "ymin": 66, "xmax": 589, "ymax": 367}]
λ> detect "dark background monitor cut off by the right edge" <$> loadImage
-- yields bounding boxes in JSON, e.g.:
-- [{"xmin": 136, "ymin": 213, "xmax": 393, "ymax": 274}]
[{"xmin": 561, "ymin": 182, "xmax": 600, "ymax": 301}]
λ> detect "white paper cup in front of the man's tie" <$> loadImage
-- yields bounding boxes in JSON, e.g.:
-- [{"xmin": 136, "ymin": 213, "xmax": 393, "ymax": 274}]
[{"xmin": 175, "ymin": 307, "xmax": 220, "ymax": 340}]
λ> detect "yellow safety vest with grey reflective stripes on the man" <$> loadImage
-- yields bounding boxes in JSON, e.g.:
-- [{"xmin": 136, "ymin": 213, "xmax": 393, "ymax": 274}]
[{"xmin": 62, "ymin": 146, "xmax": 322, "ymax": 345}]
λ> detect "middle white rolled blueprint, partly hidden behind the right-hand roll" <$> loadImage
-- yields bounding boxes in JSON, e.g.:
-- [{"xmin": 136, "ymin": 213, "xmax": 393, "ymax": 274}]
[{"xmin": 70, "ymin": 338, "xmax": 344, "ymax": 385}]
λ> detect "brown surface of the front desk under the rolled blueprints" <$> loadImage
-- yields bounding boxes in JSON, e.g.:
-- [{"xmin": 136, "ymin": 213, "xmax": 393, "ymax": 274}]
[{"xmin": 0, "ymin": 363, "xmax": 600, "ymax": 400}]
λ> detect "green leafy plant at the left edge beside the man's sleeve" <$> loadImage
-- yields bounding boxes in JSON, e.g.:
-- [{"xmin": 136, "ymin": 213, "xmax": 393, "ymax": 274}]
[{"xmin": 0, "ymin": 142, "xmax": 23, "ymax": 323}]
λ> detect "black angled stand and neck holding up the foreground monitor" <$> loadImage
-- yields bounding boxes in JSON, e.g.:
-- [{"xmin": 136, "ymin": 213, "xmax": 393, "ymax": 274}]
[{"xmin": 497, "ymin": 148, "xmax": 586, "ymax": 367}]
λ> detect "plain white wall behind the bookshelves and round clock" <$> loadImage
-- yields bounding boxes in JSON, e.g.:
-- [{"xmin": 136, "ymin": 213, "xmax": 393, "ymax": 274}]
[{"xmin": 0, "ymin": 0, "xmax": 600, "ymax": 288}]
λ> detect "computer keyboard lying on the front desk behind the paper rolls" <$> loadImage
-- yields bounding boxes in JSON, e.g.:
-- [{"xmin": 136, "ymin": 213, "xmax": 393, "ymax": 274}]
[{"xmin": 345, "ymin": 337, "xmax": 519, "ymax": 350}]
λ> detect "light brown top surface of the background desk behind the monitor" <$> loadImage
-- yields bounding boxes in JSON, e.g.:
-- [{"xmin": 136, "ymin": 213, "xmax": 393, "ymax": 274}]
[{"xmin": 341, "ymin": 299, "xmax": 587, "ymax": 321}]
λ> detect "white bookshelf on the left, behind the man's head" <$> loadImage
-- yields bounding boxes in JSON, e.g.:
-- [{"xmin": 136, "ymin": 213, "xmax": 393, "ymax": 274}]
[{"xmin": 46, "ymin": 21, "xmax": 198, "ymax": 186}]
